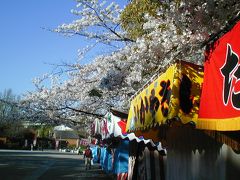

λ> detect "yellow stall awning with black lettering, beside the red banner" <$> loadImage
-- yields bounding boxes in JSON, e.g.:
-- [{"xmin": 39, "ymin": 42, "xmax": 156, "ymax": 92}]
[{"xmin": 126, "ymin": 61, "xmax": 203, "ymax": 131}]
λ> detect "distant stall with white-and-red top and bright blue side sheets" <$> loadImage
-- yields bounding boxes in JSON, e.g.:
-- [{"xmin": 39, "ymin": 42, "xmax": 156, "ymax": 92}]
[{"xmin": 92, "ymin": 112, "xmax": 128, "ymax": 179}]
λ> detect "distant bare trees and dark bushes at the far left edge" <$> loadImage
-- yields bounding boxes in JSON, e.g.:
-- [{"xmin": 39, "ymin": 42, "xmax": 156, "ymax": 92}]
[{"xmin": 0, "ymin": 89, "xmax": 58, "ymax": 149}]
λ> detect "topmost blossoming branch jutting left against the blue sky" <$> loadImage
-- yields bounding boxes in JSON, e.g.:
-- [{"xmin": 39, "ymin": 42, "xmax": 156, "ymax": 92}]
[{"xmin": 54, "ymin": 0, "xmax": 133, "ymax": 45}]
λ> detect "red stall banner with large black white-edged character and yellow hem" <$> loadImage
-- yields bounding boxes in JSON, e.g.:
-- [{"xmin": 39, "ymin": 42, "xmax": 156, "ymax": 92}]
[{"xmin": 197, "ymin": 22, "xmax": 240, "ymax": 131}]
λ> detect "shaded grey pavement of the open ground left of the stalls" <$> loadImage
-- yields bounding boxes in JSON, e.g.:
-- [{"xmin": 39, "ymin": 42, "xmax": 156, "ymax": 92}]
[{"xmin": 0, "ymin": 150, "xmax": 112, "ymax": 180}]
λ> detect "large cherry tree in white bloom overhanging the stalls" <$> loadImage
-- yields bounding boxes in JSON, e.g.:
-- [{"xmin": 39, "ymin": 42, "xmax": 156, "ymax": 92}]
[{"xmin": 23, "ymin": 0, "xmax": 240, "ymax": 127}]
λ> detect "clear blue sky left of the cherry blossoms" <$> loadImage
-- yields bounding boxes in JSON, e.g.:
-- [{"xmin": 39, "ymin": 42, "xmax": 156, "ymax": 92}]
[{"xmin": 0, "ymin": 0, "xmax": 124, "ymax": 95}]
